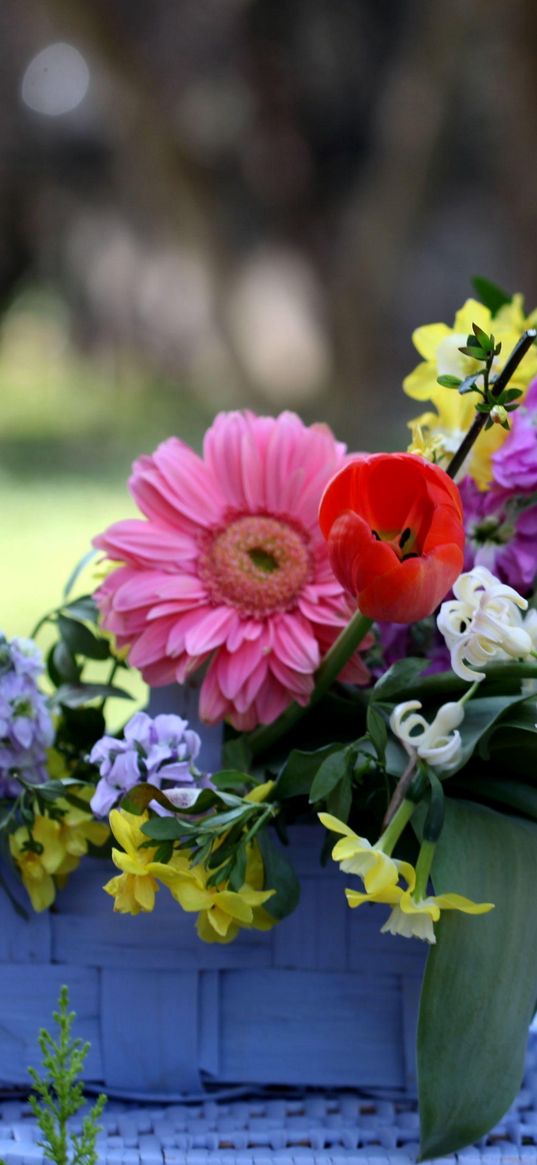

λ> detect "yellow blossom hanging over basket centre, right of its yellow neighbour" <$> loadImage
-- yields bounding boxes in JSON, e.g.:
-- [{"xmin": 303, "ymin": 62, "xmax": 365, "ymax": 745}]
[{"xmin": 162, "ymin": 842, "xmax": 276, "ymax": 942}]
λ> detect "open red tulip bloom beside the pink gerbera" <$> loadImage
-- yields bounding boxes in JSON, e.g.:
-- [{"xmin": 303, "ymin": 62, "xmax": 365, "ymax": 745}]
[{"xmin": 319, "ymin": 453, "xmax": 465, "ymax": 623}]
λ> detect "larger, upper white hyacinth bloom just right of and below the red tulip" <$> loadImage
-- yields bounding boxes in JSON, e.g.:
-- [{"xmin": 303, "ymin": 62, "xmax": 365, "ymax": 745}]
[{"xmin": 437, "ymin": 566, "xmax": 534, "ymax": 682}]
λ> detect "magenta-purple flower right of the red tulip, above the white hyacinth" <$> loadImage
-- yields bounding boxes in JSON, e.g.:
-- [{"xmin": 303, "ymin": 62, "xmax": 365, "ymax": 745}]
[{"xmin": 459, "ymin": 477, "xmax": 537, "ymax": 594}]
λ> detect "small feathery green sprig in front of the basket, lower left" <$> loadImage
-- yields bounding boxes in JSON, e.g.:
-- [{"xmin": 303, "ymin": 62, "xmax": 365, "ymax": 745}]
[{"xmin": 28, "ymin": 987, "xmax": 106, "ymax": 1165}]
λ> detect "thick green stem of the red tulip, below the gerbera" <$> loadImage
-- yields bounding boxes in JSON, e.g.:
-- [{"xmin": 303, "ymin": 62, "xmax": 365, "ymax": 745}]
[{"xmin": 246, "ymin": 610, "xmax": 370, "ymax": 756}]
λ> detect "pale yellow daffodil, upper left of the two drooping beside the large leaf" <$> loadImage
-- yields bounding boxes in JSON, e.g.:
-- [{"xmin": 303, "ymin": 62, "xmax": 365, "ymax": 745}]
[{"xmin": 319, "ymin": 813, "xmax": 415, "ymax": 901}]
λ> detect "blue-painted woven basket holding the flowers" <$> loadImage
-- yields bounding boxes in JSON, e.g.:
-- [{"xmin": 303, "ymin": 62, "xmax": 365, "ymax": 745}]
[{"xmin": 0, "ymin": 826, "xmax": 425, "ymax": 1096}]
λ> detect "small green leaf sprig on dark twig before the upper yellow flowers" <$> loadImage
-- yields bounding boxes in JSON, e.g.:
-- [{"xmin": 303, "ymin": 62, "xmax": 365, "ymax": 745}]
[{"xmin": 438, "ymin": 324, "xmax": 522, "ymax": 430}]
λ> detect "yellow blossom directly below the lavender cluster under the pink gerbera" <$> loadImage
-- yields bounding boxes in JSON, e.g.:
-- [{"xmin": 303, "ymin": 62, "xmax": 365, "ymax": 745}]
[{"xmin": 103, "ymin": 809, "xmax": 189, "ymax": 915}]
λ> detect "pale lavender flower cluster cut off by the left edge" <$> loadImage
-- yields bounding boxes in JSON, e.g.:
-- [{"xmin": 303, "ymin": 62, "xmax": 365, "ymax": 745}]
[{"xmin": 0, "ymin": 634, "xmax": 54, "ymax": 797}]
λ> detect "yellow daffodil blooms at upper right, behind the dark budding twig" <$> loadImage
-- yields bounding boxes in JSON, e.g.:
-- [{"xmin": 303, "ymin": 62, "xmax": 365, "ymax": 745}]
[{"xmin": 403, "ymin": 295, "xmax": 537, "ymax": 489}]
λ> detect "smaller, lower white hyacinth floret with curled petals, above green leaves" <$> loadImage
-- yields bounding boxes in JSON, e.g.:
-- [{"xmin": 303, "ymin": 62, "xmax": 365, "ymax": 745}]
[{"xmin": 390, "ymin": 700, "xmax": 465, "ymax": 768}]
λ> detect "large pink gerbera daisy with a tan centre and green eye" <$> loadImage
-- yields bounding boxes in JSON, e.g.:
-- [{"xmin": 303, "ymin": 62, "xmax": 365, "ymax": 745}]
[{"xmin": 94, "ymin": 412, "xmax": 368, "ymax": 730}]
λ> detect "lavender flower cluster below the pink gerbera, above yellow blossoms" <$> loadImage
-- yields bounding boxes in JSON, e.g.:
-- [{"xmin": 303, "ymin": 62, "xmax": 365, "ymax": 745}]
[{"xmin": 90, "ymin": 712, "xmax": 206, "ymax": 817}]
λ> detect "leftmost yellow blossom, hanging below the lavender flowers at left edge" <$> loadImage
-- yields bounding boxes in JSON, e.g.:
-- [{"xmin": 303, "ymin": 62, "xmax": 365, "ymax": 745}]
[{"xmin": 9, "ymin": 817, "xmax": 65, "ymax": 912}]
